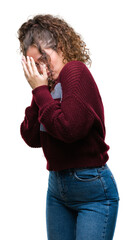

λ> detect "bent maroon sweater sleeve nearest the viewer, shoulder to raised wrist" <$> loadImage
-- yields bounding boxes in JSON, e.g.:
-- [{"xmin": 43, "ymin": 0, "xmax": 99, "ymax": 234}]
[{"xmin": 32, "ymin": 61, "xmax": 104, "ymax": 143}]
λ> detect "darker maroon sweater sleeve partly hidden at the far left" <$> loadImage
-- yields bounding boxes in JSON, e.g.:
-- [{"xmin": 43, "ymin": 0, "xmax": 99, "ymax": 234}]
[{"xmin": 20, "ymin": 98, "xmax": 41, "ymax": 147}]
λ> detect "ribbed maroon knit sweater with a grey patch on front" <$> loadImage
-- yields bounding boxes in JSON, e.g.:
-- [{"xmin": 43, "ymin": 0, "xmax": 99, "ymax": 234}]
[{"xmin": 20, "ymin": 61, "xmax": 109, "ymax": 171}]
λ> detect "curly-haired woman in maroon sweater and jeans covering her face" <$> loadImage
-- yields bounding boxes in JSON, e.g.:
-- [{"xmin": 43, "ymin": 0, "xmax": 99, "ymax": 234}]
[{"xmin": 18, "ymin": 15, "xmax": 119, "ymax": 240}]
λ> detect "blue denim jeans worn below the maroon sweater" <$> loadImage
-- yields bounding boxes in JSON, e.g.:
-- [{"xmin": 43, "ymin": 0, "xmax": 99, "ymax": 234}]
[{"xmin": 46, "ymin": 164, "xmax": 119, "ymax": 240}]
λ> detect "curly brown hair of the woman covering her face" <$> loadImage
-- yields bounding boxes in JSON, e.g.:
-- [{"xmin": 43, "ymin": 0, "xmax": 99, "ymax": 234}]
[{"xmin": 18, "ymin": 14, "xmax": 91, "ymax": 90}]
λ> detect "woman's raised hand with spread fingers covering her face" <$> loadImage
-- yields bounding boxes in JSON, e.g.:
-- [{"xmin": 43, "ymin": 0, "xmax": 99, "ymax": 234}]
[{"xmin": 22, "ymin": 56, "xmax": 48, "ymax": 89}]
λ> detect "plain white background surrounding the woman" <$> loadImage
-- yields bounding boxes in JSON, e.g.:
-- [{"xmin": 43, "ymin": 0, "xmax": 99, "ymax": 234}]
[{"xmin": 0, "ymin": 0, "xmax": 138, "ymax": 240}]
